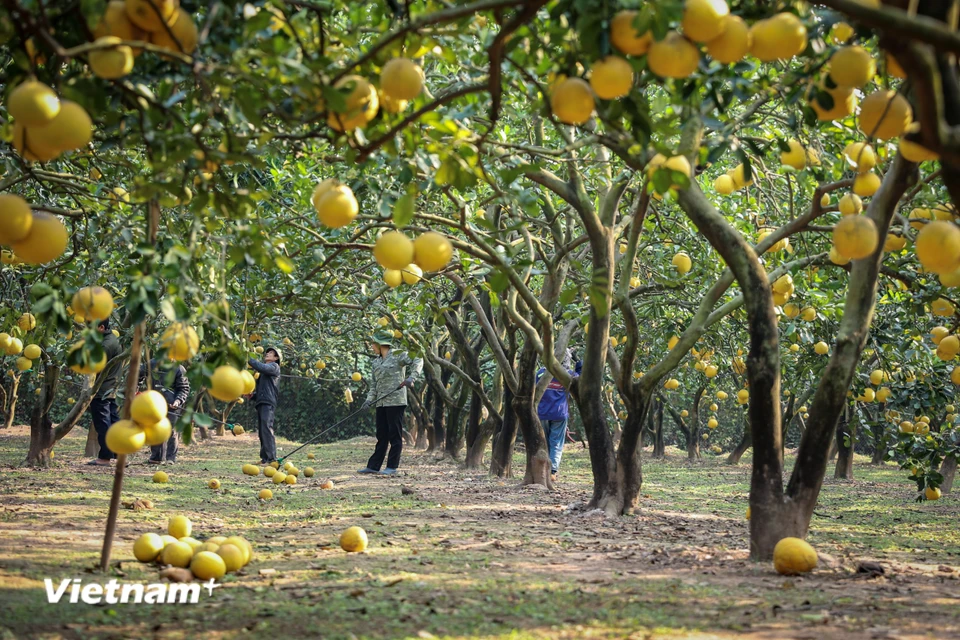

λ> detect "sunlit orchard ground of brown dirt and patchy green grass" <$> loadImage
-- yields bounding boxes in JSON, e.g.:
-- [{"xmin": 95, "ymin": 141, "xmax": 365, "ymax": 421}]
[{"xmin": 0, "ymin": 427, "xmax": 960, "ymax": 640}]
